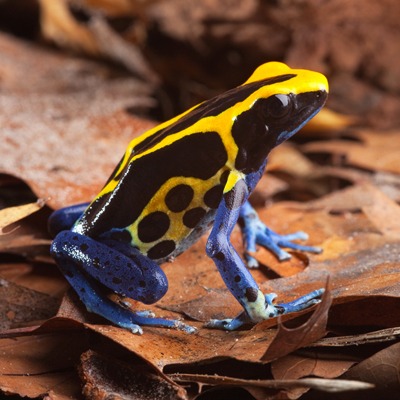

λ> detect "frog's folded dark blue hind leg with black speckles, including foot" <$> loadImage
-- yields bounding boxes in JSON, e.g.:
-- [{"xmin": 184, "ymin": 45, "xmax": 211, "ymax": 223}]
[{"xmin": 51, "ymin": 231, "xmax": 194, "ymax": 333}]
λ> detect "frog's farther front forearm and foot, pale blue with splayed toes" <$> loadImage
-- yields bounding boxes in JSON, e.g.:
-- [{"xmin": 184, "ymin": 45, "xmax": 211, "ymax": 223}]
[{"xmin": 240, "ymin": 202, "xmax": 322, "ymax": 268}]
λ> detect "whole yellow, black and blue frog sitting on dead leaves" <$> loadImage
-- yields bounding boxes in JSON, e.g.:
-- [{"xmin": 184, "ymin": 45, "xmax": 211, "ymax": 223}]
[{"xmin": 49, "ymin": 62, "xmax": 328, "ymax": 333}]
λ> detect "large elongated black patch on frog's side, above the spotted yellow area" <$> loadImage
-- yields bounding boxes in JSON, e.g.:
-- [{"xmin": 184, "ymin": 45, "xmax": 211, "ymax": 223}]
[{"xmin": 79, "ymin": 132, "xmax": 228, "ymax": 237}]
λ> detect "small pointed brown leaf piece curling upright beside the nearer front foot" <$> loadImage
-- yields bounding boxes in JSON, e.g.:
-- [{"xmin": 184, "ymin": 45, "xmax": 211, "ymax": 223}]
[{"xmin": 261, "ymin": 285, "xmax": 332, "ymax": 362}]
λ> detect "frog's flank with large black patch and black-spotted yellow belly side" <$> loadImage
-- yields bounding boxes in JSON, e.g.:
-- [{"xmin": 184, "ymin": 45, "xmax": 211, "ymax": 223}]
[{"xmin": 74, "ymin": 126, "xmax": 228, "ymax": 260}]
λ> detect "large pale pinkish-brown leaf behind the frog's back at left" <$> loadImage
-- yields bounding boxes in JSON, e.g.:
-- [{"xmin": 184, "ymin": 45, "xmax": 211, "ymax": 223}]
[{"xmin": 0, "ymin": 34, "xmax": 153, "ymax": 208}]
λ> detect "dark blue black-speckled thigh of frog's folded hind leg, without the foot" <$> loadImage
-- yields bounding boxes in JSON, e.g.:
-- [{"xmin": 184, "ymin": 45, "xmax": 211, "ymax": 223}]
[{"xmin": 51, "ymin": 231, "xmax": 168, "ymax": 304}]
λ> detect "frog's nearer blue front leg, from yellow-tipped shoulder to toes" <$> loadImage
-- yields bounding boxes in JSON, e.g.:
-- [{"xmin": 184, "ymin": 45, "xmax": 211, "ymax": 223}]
[{"xmin": 207, "ymin": 173, "xmax": 323, "ymax": 330}]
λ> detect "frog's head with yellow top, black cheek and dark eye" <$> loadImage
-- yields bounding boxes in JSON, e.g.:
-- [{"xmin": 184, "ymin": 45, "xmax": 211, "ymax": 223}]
[{"xmin": 232, "ymin": 62, "xmax": 328, "ymax": 172}]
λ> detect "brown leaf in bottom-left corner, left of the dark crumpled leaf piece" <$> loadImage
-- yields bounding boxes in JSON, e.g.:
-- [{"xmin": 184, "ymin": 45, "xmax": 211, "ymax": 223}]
[{"xmin": 0, "ymin": 332, "xmax": 87, "ymax": 400}]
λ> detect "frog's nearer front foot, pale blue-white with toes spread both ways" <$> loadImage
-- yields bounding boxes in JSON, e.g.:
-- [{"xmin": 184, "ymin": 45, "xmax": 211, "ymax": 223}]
[{"xmin": 205, "ymin": 289, "xmax": 325, "ymax": 331}]
